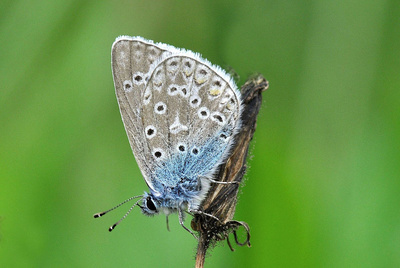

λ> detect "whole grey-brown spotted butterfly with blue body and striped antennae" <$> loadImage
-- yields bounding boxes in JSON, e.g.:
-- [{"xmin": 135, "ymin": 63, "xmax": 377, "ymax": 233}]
[{"xmin": 94, "ymin": 36, "xmax": 243, "ymax": 237}]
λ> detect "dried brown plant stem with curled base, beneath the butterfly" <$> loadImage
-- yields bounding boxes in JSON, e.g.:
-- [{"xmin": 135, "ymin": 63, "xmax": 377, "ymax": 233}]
[{"xmin": 191, "ymin": 75, "xmax": 268, "ymax": 268}]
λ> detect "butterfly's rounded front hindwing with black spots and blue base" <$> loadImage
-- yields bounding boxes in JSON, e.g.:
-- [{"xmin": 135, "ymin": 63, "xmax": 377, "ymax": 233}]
[{"xmin": 142, "ymin": 50, "xmax": 241, "ymax": 191}]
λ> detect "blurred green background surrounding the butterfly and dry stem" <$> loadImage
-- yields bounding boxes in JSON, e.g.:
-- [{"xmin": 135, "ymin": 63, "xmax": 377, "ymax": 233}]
[{"xmin": 0, "ymin": 0, "xmax": 400, "ymax": 267}]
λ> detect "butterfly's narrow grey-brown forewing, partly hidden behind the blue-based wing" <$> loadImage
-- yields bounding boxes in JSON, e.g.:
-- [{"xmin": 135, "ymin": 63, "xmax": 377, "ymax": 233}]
[{"xmin": 111, "ymin": 36, "xmax": 175, "ymax": 188}]
